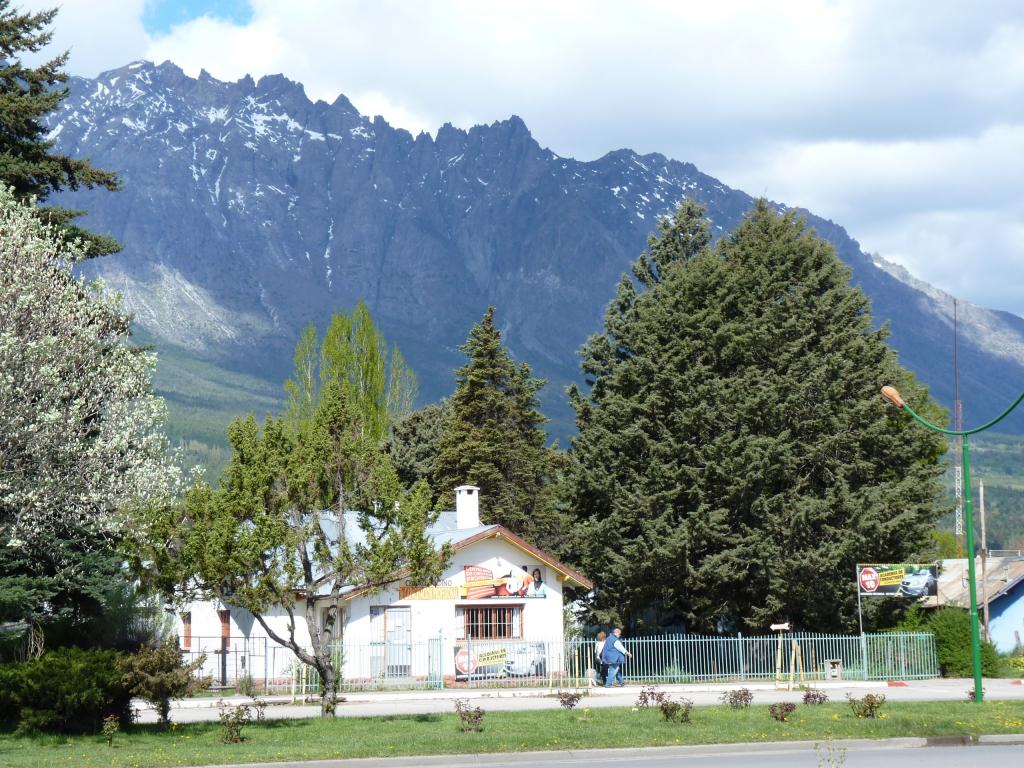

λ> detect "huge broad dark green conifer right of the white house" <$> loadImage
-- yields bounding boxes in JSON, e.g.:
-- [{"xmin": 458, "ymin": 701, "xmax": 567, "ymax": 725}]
[{"xmin": 571, "ymin": 203, "xmax": 945, "ymax": 632}]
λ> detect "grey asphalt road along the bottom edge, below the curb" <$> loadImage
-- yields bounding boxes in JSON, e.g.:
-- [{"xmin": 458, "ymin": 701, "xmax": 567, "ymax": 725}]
[{"xmin": 188, "ymin": 738, "xmax": 1024, "ymax": 768}]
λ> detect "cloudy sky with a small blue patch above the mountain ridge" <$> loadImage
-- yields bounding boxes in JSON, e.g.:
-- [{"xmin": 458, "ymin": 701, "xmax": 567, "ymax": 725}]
[{"xmin": 28, "ymin": 0, "xmax": 1024, "ymax": 315}]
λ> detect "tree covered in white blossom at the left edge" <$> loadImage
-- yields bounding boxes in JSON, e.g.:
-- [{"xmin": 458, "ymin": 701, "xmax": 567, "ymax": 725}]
[{"xmin": 0, "ymin": 188, "xmax": 178, "ymax": 634}]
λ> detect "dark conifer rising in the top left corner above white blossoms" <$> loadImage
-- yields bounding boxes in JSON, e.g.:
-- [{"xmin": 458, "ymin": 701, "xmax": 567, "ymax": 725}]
[{"xmin": 0, "ymin": 0, "xmax": 121, "ymax": 257}]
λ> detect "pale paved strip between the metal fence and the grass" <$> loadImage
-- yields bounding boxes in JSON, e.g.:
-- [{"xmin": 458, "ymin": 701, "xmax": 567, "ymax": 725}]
[{"xmin": 146, "ymin": 680, "xmax": 1024, "ymax": 729}]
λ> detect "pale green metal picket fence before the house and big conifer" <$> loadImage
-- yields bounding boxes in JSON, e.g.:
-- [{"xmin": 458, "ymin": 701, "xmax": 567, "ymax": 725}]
[{"xmin": 178, "ymin": 633, "xmax": 939, "ymax": 696}]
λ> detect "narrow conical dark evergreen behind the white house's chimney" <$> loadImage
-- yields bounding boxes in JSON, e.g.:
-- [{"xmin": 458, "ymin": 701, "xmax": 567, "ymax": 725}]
[{"xmin": 434, "ymin": 307, "xmax": 557, "ymax": 542}]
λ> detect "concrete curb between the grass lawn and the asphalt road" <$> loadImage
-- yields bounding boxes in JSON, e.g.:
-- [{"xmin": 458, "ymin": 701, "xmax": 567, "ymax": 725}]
[{"xmin": 186, "ymin": 734, "xmax": 974, "ymax": 768}]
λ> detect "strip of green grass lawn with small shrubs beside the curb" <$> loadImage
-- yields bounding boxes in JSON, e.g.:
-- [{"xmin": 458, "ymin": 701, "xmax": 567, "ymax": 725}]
[{"xmin": 0, "ymin": 701, "xmax": 1024, "ymax": 768}]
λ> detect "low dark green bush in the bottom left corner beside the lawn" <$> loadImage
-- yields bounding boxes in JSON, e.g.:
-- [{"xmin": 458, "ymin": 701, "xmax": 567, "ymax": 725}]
[{"xmin": 0, "ymin": 648, "xmax": 131, "ymax": 733}]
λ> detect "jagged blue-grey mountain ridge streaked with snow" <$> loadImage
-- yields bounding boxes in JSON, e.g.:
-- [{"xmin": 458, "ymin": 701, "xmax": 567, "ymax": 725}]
[{"xmin": 50, "ymin": 61, "xmax": 1024, "ymax": 432}]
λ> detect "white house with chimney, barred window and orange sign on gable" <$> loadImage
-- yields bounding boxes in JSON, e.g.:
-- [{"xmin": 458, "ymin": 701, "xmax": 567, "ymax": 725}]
[{"xmin": 178, "ymin": 485, "xmax": 593, "ymax": 686}]
